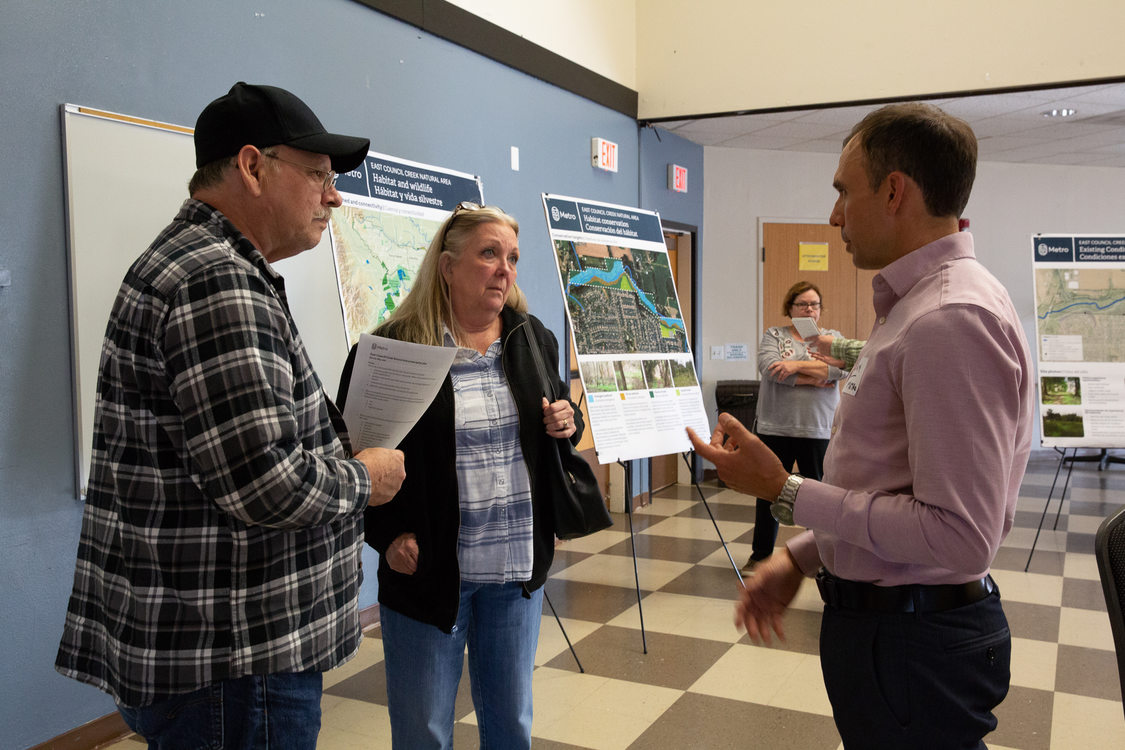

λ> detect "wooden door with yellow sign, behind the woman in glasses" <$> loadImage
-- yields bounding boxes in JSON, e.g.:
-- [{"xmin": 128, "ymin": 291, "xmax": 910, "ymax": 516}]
[{"xmin": 762, "ymin": 223, "xmax": 875, "ymax": 338}]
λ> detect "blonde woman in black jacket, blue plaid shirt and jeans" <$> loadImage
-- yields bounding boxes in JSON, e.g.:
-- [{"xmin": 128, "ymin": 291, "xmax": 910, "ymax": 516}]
[{"xmin": 339, "ymin": 202, "xmax": 583, "ymax": 750}]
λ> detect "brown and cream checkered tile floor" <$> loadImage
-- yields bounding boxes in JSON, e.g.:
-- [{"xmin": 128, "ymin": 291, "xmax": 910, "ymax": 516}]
[{"xmin": 109, "ymin": 453, "xmax": 1125, "ymax": 750}]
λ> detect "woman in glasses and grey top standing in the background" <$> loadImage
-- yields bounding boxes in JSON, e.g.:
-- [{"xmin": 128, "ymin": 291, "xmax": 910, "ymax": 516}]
[{"xmin": 743, "ymin": 281, "xmax": 846, "ymax": 575}]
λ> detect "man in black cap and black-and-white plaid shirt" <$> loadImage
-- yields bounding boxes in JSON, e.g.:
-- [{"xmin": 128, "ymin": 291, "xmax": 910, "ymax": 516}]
[{"xmin": 55, "ymin": 83, "xmax": 405, "ymax": 748}]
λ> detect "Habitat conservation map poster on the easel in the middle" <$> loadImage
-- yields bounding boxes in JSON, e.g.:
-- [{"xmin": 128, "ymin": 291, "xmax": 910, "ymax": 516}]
[{"xmin": 543, "ymin": 193, "xmax": 711, "ymax": 463}]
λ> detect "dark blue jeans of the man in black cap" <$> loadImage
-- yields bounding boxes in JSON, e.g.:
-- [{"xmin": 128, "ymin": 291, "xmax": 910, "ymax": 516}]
[{"xmin": 117, "ymin": 672, "xmax": 323, "ymax": 750}]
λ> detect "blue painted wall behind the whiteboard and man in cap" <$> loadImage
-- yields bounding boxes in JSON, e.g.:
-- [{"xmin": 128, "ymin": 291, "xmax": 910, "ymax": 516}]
[{"xmin": 0, "ymin": 0, "xmax": 703, "ymax": 749}]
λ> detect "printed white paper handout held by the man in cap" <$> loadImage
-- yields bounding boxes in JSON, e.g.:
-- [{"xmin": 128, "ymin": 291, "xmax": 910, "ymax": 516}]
[{"xmin": 344, "ymin": 334, "xmax": 457, "ymax": 451}]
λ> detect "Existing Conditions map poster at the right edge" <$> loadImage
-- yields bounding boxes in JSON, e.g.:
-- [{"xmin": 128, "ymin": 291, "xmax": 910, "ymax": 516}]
[{"xmin": 1032, "ymin": 234, "xmax": 1125, "ymax": 449}]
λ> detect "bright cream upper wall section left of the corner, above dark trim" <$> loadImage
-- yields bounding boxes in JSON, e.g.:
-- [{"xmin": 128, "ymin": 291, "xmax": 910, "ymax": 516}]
[{"xmin": 449, "ymin": 0, "xmax": 644, "ymax": 90}]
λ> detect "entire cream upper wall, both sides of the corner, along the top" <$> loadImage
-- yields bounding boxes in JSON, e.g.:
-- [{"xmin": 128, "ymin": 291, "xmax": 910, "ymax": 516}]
[{"xmin": 452, "ymin": 0, "xmax": 1125, "ymax": 119}]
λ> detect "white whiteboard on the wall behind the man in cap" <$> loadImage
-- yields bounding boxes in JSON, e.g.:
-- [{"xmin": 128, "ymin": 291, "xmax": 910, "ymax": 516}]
[{"xmin": 62, "ymin": 105, "xmax": 348, "ymax": 497}]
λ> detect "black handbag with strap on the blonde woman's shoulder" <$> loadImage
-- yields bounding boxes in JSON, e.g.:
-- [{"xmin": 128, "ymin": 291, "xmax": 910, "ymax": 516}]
[{"xmin": 523, "ymin": 320, "xmax": 613, "ymax": 539}]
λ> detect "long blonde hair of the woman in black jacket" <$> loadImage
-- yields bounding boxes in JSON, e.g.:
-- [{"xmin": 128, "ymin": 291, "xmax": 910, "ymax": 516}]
[{"xmin": 376, "ymin": 204, "xmax": 528, "ymax": 346}]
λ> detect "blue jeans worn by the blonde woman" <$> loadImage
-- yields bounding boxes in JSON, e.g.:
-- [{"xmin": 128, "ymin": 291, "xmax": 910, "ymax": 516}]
[{"xmin": 379, "ymin": 581, "xmax": 543, "ymax": 750}]
